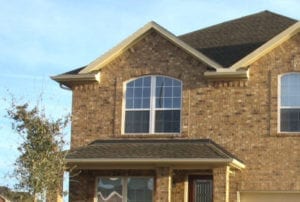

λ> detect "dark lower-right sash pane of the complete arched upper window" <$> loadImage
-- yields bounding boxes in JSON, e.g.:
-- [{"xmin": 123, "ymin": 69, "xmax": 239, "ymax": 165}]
[{"xmin": 155, "ymin": 110, "xmax": 180, "ymax": 133}]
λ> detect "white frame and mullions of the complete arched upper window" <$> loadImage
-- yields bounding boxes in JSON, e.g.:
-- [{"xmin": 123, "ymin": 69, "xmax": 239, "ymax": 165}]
[{"xmin": 122, "ymin": 75, "xmax": 183, "ymax": 135}]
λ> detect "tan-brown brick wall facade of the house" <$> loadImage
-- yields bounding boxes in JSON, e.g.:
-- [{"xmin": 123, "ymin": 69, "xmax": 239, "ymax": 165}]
[{"xmin": 70, "ymin": 31, "xmax": 300, "ymax": 202}]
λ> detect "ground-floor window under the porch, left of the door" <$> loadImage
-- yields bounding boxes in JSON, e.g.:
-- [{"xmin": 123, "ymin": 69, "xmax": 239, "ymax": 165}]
[{"xmin": 97, "ymin": 177, "xmax": 153, "ymax": 202}]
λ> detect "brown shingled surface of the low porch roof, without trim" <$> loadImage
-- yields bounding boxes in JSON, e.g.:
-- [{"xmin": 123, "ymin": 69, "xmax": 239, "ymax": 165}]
[{"xmin": 67, "ymin": 139, "xmax": 237, "ymax": 159}]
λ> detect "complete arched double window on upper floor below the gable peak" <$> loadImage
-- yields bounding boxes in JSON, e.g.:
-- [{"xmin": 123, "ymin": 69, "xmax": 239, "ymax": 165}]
[{"xmin": 124, "ymin": 76, "xmax": 182, "ymax": 133}]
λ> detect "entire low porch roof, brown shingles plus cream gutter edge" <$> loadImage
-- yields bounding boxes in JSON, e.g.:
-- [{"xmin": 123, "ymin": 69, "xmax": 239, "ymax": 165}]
[{"xmin": 66, "ymin": 139, "xmax": 245, "ymax": 169}]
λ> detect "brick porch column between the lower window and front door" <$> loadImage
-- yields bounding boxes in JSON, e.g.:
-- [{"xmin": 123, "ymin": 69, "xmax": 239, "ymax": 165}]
[{"xmin": 155, "ymin": 167, "xmax": 172, "ymax": 202}]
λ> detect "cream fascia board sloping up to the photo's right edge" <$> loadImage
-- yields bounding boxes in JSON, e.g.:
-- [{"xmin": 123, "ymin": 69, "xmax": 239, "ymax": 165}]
[{"xmin": 228, "ymin": 21, "xmax": 300, "ymax": 71}]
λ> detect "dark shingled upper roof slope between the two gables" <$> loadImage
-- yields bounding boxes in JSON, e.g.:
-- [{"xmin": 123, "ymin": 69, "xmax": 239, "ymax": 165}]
[{"xmin": 179, "ymin": 11, "xmax": 297, "ymax": 67}]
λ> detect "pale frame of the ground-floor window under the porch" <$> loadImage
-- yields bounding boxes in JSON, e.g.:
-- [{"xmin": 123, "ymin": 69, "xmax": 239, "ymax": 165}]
[{"xmin": 94, "ymin": 176, "xmax": 155, "ymax": 202}]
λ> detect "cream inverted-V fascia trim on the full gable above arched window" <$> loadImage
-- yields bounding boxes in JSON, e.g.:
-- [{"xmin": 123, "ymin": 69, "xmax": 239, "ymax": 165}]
[{"xmin": 79, "ymin": 21, "xmax": 223, "ymax": 74}]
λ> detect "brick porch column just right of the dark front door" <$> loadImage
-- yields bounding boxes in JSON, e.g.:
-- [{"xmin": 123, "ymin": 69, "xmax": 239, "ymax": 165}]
[{"xmin": 213, "ymin": 166, "xmax": 230, "ymax": 202}]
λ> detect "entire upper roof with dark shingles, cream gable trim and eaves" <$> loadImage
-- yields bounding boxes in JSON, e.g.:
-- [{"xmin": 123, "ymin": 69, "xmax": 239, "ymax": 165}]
[{"xmin": 51, "ymin": 11, "xmax": 300, "ymax": 83}]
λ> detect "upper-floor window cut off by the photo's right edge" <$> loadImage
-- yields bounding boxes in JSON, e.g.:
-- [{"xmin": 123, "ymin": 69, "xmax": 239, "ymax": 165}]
[{"xmin": 279, "ymin": 73, "xmax": 300, "ymax": 132}]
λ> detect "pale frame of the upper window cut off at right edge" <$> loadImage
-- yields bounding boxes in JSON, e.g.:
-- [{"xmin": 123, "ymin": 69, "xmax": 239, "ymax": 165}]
[{"xmin": 277, "ymin": 72, "xmax": 300, "ymax": 134}]
